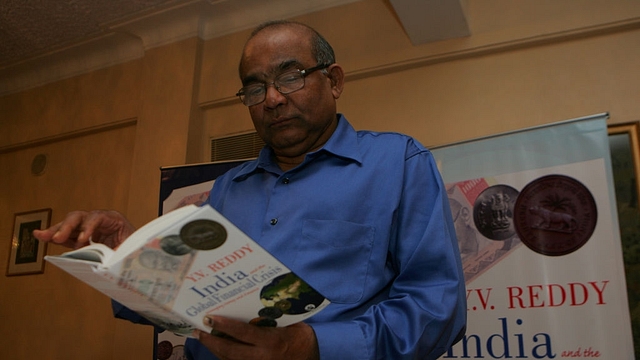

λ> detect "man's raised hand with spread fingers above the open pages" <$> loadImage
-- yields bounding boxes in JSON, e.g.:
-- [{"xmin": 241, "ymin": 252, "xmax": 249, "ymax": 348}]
[{"xmin": 33, "ymin": 210, "xmax": 136, "ymax": 249}]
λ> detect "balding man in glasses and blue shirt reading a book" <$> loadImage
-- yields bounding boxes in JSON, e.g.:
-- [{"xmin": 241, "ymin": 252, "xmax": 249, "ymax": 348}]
[{"xmin": 36, "ymin": 21, "xmax": 466, "ymax": 360}]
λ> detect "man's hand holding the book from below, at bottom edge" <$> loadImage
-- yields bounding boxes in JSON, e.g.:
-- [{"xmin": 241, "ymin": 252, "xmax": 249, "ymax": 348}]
[{"xmin": 195, "ymin": 316, "xmax": 320, "ymax": 360}]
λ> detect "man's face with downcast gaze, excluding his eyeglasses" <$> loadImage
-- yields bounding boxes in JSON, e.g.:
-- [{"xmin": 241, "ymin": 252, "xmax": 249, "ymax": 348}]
[{"xmin": 240, "ymin": 26, "xmax": 342, "ymax": 158}]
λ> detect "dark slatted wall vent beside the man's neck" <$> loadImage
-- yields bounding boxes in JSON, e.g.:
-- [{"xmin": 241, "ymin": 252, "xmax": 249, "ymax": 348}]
[{"xmin": 211, "ymin": 132, "xmax": 264, "ymax": 161}]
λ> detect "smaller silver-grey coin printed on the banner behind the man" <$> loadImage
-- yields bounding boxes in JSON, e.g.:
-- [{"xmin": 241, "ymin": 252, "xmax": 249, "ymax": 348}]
[{"xmin": 473, "ymin": 185, "xmax": 518, "ymax": 240}]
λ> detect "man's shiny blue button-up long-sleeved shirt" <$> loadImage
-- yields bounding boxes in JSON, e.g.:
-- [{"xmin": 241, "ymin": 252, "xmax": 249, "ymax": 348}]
[{"xmin": 116, "ymin": 115, "xmax": 466, "ymax": 360}]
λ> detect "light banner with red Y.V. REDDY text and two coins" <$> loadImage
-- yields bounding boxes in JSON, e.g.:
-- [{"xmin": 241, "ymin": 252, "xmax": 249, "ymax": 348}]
[{"xmin": 432, "ymin": 114, "xmax": 634, "ymax": 359}]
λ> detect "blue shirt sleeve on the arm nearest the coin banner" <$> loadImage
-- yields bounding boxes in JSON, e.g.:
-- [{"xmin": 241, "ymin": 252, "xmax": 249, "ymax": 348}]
[{"xmin": 310, "ymin": 149, "xmax": 467, "ymax": 359}]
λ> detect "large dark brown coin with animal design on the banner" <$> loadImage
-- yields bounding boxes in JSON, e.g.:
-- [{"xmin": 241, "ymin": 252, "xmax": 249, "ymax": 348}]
[{"xmin": 514, "ymin": 174, "xmax": 598, "ymax": 256}]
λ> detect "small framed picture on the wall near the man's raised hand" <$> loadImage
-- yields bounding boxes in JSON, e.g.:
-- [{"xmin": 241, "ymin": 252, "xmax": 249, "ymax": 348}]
[{"xmin": 6, "ymin": 209, "xmax": 51, "ymax": 276}]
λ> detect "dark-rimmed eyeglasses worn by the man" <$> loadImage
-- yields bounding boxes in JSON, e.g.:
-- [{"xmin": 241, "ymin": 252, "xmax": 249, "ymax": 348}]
[{"xmin": 236, "ymin": 64, "xmax": 331, "ymax": 106}]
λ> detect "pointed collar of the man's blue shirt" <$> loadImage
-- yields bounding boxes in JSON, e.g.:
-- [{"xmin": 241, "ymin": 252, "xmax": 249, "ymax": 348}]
[{"xmin": 234, "ymin": 114, "xmax": 362, "ymax": 180}]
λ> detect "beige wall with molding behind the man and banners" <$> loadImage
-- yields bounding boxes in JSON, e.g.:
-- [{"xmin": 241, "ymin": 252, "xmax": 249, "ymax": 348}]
[{"xmin": 0, "ymin": 0, "xmax": 640, "ymax": 360}]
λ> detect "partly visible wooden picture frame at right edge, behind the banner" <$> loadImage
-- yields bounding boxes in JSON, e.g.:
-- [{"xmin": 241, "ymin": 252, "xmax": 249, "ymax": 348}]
[{"xmin": 608, "ymin": 122, "xmax": 640, "ymax": 358}]
